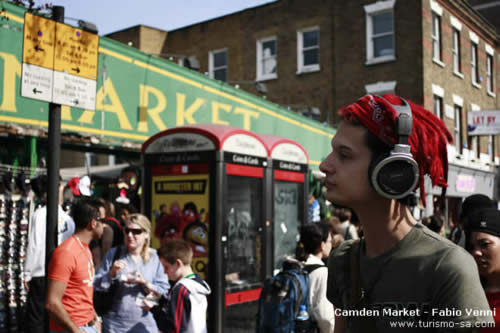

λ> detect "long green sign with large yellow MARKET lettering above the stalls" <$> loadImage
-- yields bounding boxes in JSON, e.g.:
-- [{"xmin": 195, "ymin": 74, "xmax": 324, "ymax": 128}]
[{"xmin": 0, "ymin": 2, "xmax": 335, "ymax": 168}]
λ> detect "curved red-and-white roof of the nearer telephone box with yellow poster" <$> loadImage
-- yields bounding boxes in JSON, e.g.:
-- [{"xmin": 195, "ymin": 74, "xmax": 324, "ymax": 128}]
[{"xmin": 142, "ymin": 124, "xmax": 269, "ymax": 157}]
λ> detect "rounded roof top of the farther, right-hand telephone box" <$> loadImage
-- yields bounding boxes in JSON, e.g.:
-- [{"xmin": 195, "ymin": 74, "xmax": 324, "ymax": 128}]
[{"xmin": 259, "ymin": 134, "xmax": 309, "ymax": 164}]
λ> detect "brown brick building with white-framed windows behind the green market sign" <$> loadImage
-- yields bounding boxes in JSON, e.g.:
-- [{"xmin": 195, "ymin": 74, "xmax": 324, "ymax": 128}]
[{"xmin": 108, "ymin": 0, "xmax": 500, "ymax": 219}]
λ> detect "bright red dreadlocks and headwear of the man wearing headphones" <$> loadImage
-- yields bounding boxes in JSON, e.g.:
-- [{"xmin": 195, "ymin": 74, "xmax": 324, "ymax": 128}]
[{"xmin": 339, "ymin": 94, "xmax": 453, "ymax": 206}]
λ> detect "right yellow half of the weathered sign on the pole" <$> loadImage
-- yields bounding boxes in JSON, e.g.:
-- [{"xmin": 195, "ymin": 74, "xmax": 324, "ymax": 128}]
[{"xmin": 54, "ymin": 23, "xmax": 99, "ymax": 80}]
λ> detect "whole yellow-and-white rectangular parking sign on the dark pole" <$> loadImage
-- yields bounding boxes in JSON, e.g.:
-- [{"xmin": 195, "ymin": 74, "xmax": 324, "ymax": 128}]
[{"xmin": 21, "ymin": 12, "xmax": 99, "ymax": 110}]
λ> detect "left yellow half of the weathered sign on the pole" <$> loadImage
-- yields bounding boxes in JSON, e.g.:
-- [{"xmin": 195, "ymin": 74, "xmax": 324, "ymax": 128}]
[{"xmin": 23, "ymin": 13, "xmax": 56, "ymax": 69}]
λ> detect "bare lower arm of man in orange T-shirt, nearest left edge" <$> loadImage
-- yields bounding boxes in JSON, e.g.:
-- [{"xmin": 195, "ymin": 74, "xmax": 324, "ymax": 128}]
[{"xmin": 45, "ymin": 279, "xmax": 81, "ymax": 333}]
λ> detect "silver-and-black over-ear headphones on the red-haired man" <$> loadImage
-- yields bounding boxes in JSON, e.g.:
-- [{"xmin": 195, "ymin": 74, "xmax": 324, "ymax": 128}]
[{"xmin": 369, "ymin": 96, "xmax": 419, "ymax": 199}]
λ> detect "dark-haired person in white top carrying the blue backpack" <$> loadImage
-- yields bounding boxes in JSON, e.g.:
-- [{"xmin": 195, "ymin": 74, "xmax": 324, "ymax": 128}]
[{"xmin": 296, "ymin": 222, "xmax": 335, "ymax": 333}]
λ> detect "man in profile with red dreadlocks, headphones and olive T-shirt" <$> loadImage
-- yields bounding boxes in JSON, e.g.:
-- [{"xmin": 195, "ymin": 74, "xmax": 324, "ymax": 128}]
[{"xmin": 320, "ymin": 94, "xmax": 493, "ymax": 333}]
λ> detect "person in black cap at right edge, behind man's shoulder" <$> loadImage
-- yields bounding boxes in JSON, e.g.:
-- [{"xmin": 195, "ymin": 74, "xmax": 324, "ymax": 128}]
[{"xmin": 466, "ymin": 208, "xmax": 500, "ymax": 333}]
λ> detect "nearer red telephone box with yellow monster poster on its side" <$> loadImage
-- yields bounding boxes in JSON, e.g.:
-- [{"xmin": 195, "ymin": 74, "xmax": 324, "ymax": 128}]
[{"xmin": 142, "ymin": 124, "xmax": 272, "ymax": 332}]
